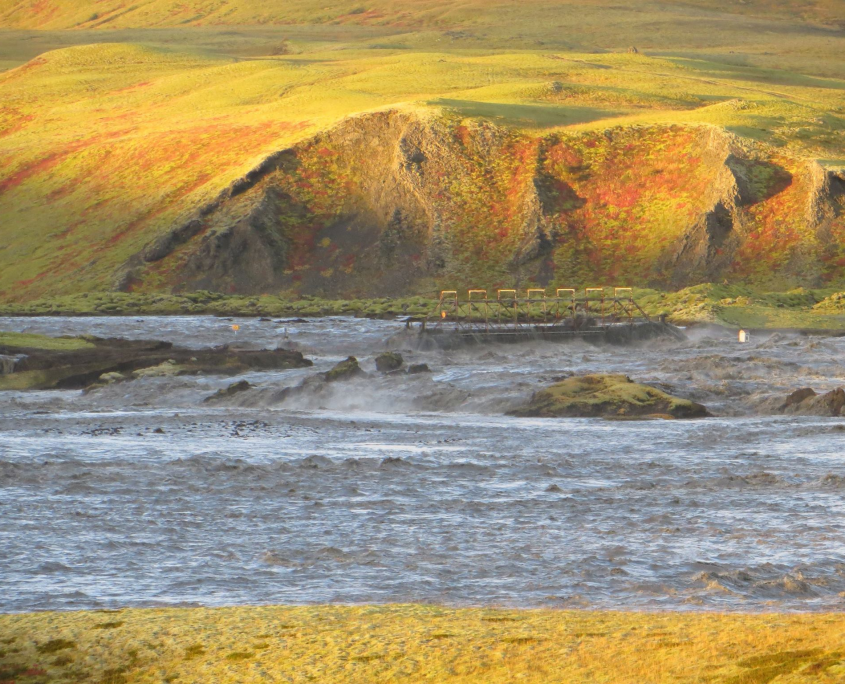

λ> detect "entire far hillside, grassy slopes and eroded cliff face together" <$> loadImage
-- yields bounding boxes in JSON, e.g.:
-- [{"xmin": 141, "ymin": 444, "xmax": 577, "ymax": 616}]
[{"xmin": 0, "ymin": 0, "xmax": 845, "ymax": 301}]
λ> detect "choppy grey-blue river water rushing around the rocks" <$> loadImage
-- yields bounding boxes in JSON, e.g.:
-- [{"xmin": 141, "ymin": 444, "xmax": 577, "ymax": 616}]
[{"xmin": 0, "ymin": 317, "xmax": 845, "ymax": 611}]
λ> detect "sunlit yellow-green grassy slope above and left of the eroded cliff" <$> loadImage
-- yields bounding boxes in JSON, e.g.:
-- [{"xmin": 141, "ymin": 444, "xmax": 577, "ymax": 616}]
[{"xmin": 0, "ymin": 0, "xmax": 845, "ymax": 300}]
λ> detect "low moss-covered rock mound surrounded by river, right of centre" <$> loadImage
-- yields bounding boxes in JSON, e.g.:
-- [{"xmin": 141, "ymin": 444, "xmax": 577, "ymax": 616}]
[{"xmin": 509, "ymin": 375, "xmax": 710, "ymax": 418}]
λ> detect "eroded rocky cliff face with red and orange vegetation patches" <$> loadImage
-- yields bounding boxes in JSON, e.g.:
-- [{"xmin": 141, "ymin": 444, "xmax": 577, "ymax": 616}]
[{"xmin": 116, "ymin": 111, "xmax": 845, "ymax": 296}]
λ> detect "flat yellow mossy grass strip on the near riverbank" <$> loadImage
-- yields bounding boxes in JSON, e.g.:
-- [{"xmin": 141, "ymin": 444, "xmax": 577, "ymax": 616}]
[{"xmin": 0, "ymin": 605, "xmax": 845, "ymax": 684}]
